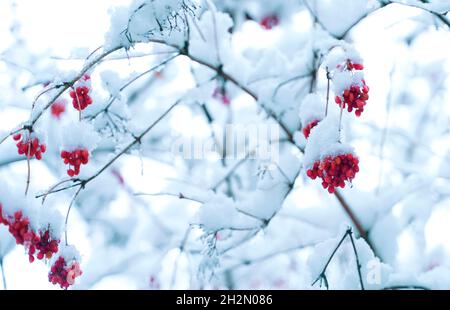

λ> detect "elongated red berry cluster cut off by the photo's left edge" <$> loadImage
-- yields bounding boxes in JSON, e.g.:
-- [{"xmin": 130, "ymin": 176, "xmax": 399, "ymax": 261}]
[{"xmin": 0, "ymin": 205, "xmax": 59, "ymax": 263}]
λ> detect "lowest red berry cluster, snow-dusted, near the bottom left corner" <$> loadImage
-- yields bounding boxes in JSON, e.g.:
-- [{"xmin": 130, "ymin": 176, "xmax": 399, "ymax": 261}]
[{"xmin": 48, "ymin": 256, "xmax": 83, "ymax": 289}]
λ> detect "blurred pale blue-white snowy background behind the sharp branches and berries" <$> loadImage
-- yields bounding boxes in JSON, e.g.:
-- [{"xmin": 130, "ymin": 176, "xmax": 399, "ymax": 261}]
[{"xmin": 0, "ymin": 0, "xmax": 450, "ymax": 289}]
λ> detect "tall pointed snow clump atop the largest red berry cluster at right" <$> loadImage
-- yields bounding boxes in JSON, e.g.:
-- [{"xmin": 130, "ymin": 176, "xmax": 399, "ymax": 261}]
[{"xmin": 303, "ymin": 114, "xmax": 354, "ymax": 169}]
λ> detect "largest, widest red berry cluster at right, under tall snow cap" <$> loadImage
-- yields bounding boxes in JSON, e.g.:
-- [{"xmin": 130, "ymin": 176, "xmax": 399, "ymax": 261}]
[{"xmin": 306, "ymin": 153, "xmax": 359, "ymax": 194}]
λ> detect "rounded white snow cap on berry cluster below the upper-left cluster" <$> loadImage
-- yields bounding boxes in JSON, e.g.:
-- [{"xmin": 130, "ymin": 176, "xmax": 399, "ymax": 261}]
[{"xmin": 61, "ymin": 121, "xmax": 100, "ymax": 152}]
